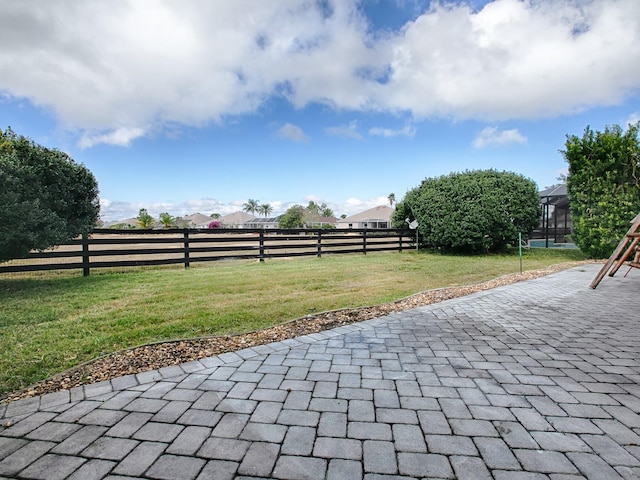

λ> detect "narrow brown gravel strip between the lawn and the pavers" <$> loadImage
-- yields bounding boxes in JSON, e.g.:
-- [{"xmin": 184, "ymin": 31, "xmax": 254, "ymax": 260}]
[{"xmin": 0, "ymin": 261, "xmax": 593, "ymax": 403}]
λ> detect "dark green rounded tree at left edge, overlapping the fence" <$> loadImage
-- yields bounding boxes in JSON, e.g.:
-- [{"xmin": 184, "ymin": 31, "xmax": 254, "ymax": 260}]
[{"xmin": 0, "ymin": 128, "xmax": 100, "ymax": 261}]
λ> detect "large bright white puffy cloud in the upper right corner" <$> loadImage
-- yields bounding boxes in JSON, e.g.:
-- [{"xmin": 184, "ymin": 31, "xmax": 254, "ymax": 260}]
[{"xmin": 381, "ymin": 0, "xmax": 640, "ymax": 119}]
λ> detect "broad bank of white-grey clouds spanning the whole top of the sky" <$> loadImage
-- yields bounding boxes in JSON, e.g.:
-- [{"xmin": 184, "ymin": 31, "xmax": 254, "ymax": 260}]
[{"xmin": 0, "ymin": 0, "xmax": 640, "ymax": 147}]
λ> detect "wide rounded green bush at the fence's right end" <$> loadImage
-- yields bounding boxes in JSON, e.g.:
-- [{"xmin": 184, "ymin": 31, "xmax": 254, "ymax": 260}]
[{"xmin": 392, "ymin": 170, "xmax": 540, "ymax": 253}]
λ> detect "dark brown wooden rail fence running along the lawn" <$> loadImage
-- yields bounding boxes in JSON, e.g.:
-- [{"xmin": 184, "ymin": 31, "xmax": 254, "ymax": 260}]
[{"xmin": 0, "ymin": 229, "xmax": 415, "ymax": 276}]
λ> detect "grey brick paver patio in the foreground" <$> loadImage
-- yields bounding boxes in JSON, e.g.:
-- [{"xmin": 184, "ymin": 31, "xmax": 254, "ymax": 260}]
[{"xmin": 0, "ymin": 265, "xmax": 640, "ymax": 480}]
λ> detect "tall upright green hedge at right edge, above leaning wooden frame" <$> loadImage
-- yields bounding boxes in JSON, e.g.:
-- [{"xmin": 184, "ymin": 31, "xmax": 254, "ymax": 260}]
[{"xmin": 561, "ymin": 122, "xmax": 640, "ymax": 258}]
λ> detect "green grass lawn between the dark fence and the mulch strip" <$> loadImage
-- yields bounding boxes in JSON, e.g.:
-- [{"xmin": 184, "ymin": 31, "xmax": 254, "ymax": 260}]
[{"xmin": 0, "ymin": 249, "xmax": 583, "ymax": 397}]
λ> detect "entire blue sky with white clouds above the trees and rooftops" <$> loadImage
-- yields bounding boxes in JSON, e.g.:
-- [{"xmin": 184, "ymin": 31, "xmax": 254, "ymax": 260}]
[{"xmin": 0, "ymin": 0, "xmax": 640, "ymax": 222}]
